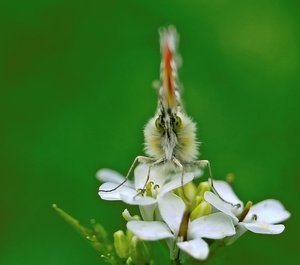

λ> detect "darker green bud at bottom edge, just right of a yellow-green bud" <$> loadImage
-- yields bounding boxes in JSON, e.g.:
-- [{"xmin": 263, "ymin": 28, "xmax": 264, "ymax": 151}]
[{"xmin": 130, "ymin": 236, "xmax": 152, "ymax": 265}]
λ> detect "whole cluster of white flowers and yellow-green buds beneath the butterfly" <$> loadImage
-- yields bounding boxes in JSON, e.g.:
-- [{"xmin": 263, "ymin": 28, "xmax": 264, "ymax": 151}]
[{"xmin": 97, "ymin": 164, "xmax": 290, "ymax": 264}]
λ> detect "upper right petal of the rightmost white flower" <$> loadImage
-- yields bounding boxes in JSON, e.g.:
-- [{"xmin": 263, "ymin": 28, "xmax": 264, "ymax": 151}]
[{"xmin": 244, "ymin": 199, "xmax": 291, "ymax": 224}]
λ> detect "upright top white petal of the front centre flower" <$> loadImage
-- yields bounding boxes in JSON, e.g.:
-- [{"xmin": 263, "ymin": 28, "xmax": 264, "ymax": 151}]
[{"xmin": 158, "ymin": 193, "xmax": 186, "ymax": 236}]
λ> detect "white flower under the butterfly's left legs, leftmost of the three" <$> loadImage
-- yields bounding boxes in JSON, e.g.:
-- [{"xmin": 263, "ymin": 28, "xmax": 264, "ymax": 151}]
[{"xmin": 96, "ymin": 164, "xmax": 199, "ymax": 220}]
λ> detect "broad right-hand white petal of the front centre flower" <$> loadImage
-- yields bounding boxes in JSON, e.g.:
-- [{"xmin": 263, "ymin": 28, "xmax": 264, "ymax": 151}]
[{"xmin": 188, "ymin": 213, "xmax": 235, "ymax": 239}]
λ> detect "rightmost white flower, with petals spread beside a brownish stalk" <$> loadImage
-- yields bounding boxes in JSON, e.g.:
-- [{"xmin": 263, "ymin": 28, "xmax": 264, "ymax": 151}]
[{"xmin": 204, "ymin": 180, "xmax": 290, "ymax": 244}]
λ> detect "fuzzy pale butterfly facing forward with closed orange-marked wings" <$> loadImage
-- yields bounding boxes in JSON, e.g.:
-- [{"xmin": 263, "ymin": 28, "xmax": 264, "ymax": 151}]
[{"xmin": 100, "ymin": 26, "xmax": 221, "ymax": 198}]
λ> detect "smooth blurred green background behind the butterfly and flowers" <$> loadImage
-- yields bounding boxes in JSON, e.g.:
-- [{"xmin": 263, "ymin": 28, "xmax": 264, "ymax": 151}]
[{"xmin": 0, "ymin": 0, "xmax": 300, "ymax": 265}]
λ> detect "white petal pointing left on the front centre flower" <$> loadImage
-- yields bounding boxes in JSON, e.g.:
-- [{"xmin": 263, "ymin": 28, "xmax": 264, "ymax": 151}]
[{"xmin": 127, "ymin": 221, "xmax": 174, "ymax": 241}]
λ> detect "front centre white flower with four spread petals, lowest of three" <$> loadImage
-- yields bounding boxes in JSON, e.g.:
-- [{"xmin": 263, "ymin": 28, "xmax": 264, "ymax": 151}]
[{"xmin": 127, "ymin": 193, "xmax": 235, "ymax": 260}]
